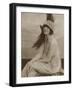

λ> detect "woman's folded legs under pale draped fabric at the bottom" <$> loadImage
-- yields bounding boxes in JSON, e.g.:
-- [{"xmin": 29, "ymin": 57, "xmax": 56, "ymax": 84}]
[{"xmin": 23, "ymin": 60, "xmax": 61, "ymax": 76}]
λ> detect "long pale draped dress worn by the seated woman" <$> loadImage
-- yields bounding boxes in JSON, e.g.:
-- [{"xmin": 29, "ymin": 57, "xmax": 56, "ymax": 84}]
[{"xmin": 21, "ymin": 37, "xmax": 61, "ymax": 77}]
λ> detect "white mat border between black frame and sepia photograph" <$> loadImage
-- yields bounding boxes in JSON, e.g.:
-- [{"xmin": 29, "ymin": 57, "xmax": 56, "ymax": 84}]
[{"xmin": 16, "ymin": 7, "xmax": 69, "ymax": 84}]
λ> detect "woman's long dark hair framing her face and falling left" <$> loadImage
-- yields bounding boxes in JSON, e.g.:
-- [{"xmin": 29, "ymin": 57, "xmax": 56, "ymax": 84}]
[{"xmin": 32, "ymin": 24, "xmax": 53, "ymax": 49}]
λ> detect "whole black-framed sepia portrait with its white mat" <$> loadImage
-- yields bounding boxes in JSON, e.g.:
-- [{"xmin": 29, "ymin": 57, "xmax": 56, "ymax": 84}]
[{"xmin": 10, "ymin": 3, "xmax": 71, "ymax": 86}]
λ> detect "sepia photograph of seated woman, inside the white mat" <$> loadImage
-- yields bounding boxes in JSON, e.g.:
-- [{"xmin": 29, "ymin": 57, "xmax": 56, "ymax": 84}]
[{"xmin": 21, "ymin": 12, "xmax": 64, "ymax": 78}]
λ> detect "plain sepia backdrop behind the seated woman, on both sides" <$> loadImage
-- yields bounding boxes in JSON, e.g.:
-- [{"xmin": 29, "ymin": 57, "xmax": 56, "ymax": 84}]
[{"xmin": 21, "ymin": 12, "xmax": 64, "ymax": 68}]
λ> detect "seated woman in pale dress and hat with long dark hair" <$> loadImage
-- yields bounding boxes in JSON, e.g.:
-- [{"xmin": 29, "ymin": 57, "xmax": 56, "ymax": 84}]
[{"xmin": 22, "ymin": 14, "xmax": 61, "ymax": 77}]
